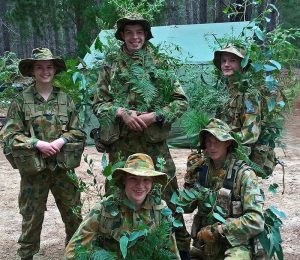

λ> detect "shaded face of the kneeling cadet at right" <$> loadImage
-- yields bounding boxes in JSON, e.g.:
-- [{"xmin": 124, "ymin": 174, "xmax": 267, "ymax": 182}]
[{"xmin": 204, "ymin": 133, "xmax": 232, "ymax": 166}]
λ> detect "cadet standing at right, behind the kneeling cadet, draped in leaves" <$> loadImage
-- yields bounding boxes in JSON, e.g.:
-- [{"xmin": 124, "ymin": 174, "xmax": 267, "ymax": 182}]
[{"xmin": 213, "ymin": 45, "xmax": 261, "ymax": 147}]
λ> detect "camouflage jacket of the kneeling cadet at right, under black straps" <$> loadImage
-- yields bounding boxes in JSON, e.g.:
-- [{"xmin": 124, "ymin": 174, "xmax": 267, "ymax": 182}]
[{"xmin": 184, "ymin": 154, "xmax": 264, "ymax": 246}]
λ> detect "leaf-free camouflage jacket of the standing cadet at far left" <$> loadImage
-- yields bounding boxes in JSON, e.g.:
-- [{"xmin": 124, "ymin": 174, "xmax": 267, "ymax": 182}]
[{"xmin": 2, "ymin": 85, "xmax": 86, "ymax": 168}]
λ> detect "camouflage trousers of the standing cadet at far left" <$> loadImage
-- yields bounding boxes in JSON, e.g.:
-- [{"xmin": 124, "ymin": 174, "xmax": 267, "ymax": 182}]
[{"xmin": 18, "ymin": 169, "xmax": 82, "ymax": 257}]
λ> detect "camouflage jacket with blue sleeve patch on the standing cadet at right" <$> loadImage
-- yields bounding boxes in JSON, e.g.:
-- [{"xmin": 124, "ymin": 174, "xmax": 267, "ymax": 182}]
[{"xmin": 216, "ymin": 86, "xmax": 261, "ymax": 145}]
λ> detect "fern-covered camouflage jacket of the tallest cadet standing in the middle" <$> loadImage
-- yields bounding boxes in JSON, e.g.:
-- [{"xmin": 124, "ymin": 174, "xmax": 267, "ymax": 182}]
[{"xmin": 93, "ymin": 48, "xmax": 187, "ymax": 131}]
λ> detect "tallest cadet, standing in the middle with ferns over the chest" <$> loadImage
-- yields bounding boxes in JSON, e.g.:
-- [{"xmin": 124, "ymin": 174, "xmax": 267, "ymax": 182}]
[{"xmin": 93, "ymin": 15, "xmax": 190, "ymax": 259}]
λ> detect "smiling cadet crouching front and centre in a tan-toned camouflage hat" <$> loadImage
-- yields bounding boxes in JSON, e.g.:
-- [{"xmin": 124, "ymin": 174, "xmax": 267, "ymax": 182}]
[{"xmin": 65, "ymin": 153, "xmax": 180, "ymax": 259}]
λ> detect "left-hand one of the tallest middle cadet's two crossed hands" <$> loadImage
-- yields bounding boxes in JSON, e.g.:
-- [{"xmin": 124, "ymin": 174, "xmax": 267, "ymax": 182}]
[{"xmin": 117, "ymin": 108, "xmax": 147, "ymax": 132}]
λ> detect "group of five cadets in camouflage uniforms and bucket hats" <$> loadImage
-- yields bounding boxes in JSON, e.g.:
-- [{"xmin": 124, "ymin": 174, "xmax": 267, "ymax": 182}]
[{"xmin": 2, "ymin": 15, "xmax": 264, "ymax": 259}]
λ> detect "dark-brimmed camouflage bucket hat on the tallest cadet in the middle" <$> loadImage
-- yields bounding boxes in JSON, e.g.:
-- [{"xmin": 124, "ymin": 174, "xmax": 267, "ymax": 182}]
[{"xmin": 115, "ymin": 14, "xmax": 153, "ymax": 41}]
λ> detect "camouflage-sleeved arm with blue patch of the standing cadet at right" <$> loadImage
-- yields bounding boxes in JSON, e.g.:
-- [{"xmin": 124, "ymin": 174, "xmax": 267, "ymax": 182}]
[{"xmin": 237, "ymin": 95, "xmax": 261, "ymax": 144}]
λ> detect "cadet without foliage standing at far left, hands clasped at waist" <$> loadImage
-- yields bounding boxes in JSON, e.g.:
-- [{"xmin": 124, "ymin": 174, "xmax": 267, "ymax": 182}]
[{"xmin": 2, "ymin": 48, "xmax": 86, "ymax": 259}]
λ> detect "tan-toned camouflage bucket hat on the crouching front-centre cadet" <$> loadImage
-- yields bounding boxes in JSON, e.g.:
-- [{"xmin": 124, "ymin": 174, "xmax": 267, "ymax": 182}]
[{"xmin": 112, "ymin": 153, "xmax": 167, "ymax": 187}]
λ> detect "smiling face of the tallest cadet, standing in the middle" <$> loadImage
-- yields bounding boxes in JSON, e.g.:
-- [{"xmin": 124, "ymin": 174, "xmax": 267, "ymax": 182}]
[{"xmin": 121, "ymin": 24, "xmax": 147, "ymax": 54}]
